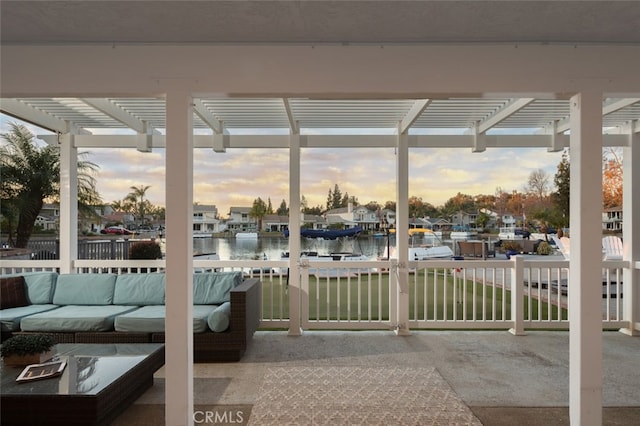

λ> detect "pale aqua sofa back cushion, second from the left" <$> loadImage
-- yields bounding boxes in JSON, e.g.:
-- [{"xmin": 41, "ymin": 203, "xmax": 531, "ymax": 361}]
[{"xmin": 53, "ymin": 274, "xmax": 117, "ymax": 305}]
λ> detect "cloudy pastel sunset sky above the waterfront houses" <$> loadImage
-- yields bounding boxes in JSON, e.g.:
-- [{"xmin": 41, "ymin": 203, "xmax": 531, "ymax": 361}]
[{"xmin": 0, "ymin": 116, "xmax": 561, "ymax": 217}]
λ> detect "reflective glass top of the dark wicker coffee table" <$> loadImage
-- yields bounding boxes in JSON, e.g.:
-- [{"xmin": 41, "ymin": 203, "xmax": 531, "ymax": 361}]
[{"xmin": 0, "ymin": 343, "xmax": 164, "ymax": 395}]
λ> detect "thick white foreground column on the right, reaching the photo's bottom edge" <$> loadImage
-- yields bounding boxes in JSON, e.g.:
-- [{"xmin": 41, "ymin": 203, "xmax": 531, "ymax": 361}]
[{"xmin": 569, "ymin": 92, "xmax": 602, "ymax": 426}]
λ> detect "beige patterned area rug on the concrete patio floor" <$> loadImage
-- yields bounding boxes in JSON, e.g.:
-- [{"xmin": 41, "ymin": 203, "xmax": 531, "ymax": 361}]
[{"xmin": 249, "ymin": 367, "xmax": 482, "ymax": 426}]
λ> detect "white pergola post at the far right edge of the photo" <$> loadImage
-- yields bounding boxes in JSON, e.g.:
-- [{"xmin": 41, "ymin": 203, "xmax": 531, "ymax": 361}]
[{"xmin": 620, "ymin": 128, "xmax": 640, "ymax": 336}]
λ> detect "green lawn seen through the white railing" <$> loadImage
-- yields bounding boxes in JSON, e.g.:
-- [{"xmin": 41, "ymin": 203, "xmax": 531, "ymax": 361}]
[{"xmin": 263, "ymin": 270, "xmax": 567, "ymax": 321}]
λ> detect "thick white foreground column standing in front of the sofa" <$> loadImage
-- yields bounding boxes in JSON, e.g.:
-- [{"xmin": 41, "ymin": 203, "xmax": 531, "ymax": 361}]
[{"xmin": 165, "ymin": 92, "xmax": 193, "ymax": 426}]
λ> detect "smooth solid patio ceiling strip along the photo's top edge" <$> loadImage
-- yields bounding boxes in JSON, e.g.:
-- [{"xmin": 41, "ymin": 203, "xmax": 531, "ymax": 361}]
[{"xmin": 0, "ymin": 0, "xmax": 640, "ymax": 44}]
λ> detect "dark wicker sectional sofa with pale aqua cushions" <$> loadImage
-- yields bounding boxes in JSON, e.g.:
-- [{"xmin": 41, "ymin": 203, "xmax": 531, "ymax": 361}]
[{"xmin": 0, "ymin": 272, "xmax": 261, "ymax": 362}]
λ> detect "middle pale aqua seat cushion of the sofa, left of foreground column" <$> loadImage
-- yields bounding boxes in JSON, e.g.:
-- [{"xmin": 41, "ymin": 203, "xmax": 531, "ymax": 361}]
[{"xmin": 20, "ymin": 305, "xmax": 136, "ymax": 332}]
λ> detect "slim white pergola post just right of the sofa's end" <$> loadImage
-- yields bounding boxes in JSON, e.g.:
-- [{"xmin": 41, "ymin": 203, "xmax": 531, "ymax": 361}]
[{"xmin": 289, "ymin": 133, "xmax": 308, "ymax": 336}]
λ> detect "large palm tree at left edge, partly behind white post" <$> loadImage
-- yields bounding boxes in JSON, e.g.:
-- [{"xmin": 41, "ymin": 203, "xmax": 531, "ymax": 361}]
[{"xmin": 0, "ymin": 123, "xmax": 101, "ymax": 248}]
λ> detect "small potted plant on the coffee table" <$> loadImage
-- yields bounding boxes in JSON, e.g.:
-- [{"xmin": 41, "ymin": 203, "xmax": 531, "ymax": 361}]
[{"xmin": 0, "ymin": 334, "xmax": 56, "ymax": 366}]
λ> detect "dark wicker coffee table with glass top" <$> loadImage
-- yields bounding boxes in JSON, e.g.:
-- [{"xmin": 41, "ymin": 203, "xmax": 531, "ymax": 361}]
[{"xmin": 0, "ymin": 343, "xmax": 164, "ymax": 426}]
